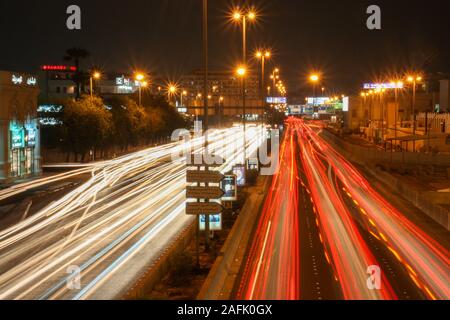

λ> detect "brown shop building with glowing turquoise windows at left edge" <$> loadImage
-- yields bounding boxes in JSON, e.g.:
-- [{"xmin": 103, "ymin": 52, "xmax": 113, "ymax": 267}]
[{"xmin": 0, "ymin": 71, "xmax": 41, "ymax": 182}]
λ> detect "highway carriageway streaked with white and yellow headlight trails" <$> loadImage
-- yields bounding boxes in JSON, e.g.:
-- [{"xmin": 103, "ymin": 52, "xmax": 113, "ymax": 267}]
[{"xmin": 0, "ymin": 127, "xmax": 262, "ymax": 299}]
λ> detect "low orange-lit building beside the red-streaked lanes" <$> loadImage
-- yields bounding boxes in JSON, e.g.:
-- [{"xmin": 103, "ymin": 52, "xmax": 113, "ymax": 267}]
[{"xmin": 346, "ymin": 81, "xmax": 449, "ymax": 151}]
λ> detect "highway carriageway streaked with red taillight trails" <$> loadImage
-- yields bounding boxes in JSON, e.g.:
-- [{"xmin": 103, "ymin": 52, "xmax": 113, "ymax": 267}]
[{"xmin": 238, "ymin": 119, "xmax": 450, "ymax": 300}]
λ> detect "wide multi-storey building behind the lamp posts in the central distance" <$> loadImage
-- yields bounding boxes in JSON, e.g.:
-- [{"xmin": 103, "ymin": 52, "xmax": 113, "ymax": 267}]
[{"xmin": 180, "ymin": 70, "xmax": 266, "ymax": 118}]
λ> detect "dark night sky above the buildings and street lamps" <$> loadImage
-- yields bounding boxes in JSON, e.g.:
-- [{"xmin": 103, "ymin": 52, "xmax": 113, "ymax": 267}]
[{"xmin": 0, "ymin": 0, "xmax": 450, "ymax": 92}]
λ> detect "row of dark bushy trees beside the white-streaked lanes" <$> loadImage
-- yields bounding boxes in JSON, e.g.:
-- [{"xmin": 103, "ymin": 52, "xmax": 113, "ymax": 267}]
[{"xmin": 42, "ymin": 94, "xmax": 187, "ymax": 162}]
